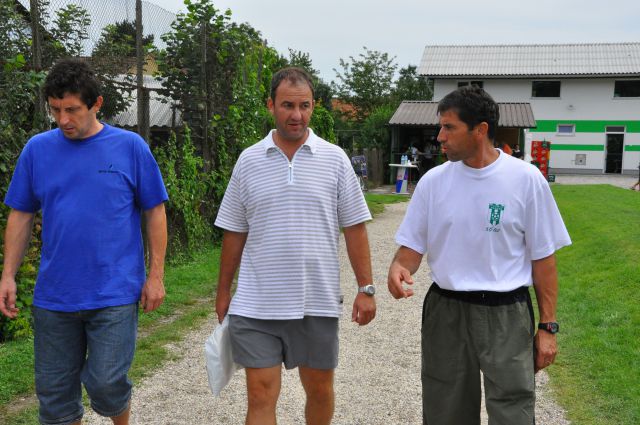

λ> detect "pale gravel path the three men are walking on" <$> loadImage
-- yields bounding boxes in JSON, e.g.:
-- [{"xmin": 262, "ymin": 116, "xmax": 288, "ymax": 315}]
[{"xmin": 85, "ymin": 203, "xmax": 569, "ymax": 425}]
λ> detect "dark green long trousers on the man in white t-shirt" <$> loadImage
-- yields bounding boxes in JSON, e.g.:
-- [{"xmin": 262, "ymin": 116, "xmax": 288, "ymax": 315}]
[{"xmin": 422, "ymin": 284, "xmax": 535, "ymax": 425}]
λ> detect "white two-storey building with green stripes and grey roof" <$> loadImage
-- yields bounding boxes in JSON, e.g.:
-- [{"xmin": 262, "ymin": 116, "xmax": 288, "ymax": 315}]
[{"xmin": 418, "ymin": 43, "xmax": 640, "ymax": 174}]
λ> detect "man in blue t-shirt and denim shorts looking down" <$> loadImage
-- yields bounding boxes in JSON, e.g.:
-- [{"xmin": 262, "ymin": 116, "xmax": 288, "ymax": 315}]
[{"xmin": 0, "ymin": 59, "xmax": 168, "ymax": 425}]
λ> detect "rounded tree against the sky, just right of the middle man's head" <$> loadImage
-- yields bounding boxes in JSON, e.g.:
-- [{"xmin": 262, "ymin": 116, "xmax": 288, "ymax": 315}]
[{"xmin": 334, "ymin": 47, "xmax": 397, "ymax": 121}]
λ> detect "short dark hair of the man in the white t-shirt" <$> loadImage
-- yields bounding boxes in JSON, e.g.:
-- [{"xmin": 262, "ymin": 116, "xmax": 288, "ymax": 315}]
[{"xmin": 438, "ymin": 85, "xmax": 500, "ymax": 141}]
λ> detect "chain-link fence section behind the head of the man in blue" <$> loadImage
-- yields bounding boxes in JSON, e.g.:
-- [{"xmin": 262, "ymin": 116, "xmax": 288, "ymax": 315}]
[{"xmin": 15, "ymin": 0, "xmax": 176, "ymax": 141}]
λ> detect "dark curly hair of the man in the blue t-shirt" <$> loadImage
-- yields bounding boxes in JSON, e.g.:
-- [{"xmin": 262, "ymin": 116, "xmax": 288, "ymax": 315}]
[{"xmin": 42, "ymin": 58, "xmax": 100, "ymax": 108}]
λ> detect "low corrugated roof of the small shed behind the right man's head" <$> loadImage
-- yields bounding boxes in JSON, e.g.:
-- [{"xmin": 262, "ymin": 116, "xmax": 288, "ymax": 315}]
[{"xmin": 389, "ymin": 101, "xmax": 536, "ymax": 128}]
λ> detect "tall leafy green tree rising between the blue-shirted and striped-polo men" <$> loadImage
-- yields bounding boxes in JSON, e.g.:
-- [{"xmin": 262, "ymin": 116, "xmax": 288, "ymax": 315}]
[{"xmin": 159, "ymin": 0, "xmax": 268, "ymax": 166}]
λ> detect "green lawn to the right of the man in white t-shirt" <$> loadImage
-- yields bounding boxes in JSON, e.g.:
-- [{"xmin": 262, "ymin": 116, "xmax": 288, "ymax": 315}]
[{"xmin": 548, "ymin": 185, "xmax": 640, "ymax": 425}]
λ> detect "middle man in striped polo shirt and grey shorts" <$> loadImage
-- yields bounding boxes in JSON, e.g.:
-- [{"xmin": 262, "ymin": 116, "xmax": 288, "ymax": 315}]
[{"xmin": 215, "ymin": 68, "xmax": 376, "ymax": 425}]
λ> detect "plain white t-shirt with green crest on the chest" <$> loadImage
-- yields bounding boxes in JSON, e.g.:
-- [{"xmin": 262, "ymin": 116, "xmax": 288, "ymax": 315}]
[{"xmin": 396, "ymin": 150, "xmax": 571, "ymax": 292}]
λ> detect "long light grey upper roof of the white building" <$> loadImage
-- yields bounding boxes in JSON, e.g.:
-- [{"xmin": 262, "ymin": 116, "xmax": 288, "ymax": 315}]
[{"xmin": 418, "ymin": 43, "xmax": 640, "ymax": 78}]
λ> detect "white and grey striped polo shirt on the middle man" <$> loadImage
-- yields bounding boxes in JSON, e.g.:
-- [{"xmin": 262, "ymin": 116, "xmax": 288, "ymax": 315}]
[{"xmin": 215, "ymin": 129, "xmax": 371, "ymax": 320}]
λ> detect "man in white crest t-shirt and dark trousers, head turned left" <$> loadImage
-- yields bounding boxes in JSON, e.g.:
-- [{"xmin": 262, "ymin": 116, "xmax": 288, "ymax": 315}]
[{"xmin": 388, "ymin": 86, "xmax": 571, "ymax": 425}]
